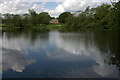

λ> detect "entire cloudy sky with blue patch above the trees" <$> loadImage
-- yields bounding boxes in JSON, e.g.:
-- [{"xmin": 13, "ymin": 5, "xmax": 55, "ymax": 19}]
[{"xmin": 0, "ymin": 0, "xmax": 117, "ymax": 17}]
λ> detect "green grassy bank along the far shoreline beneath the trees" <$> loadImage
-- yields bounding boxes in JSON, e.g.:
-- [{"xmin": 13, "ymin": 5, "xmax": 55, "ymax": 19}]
[{"xmin": 0, "ymin": 24, "xmax": 118, "ymax": 32}]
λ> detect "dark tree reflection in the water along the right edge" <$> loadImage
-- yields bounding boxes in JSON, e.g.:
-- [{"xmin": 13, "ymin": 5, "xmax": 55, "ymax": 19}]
[{"xmin": 94, "ymin": 31, "xmax": 120, "ymax": 71}]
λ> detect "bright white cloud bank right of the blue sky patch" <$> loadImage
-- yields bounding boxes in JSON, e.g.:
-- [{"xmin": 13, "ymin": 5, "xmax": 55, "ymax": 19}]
[{"xmin": 49, "ymin": 0, "xmax": 117, "ymax": 16}]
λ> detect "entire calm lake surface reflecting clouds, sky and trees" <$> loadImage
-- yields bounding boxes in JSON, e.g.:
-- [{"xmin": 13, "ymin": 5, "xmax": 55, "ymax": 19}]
[{"xmin": 0, "ymin": 31, "xmax": 120, "ymax": 78}]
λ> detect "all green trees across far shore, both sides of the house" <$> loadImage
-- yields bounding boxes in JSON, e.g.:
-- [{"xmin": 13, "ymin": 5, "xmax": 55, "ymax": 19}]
[{"xmin": 0, "ymin": 1, "xmax": 120, "ymax": 31}]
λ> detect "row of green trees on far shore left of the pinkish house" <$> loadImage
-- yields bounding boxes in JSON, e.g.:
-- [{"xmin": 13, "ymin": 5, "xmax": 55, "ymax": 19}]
[{"xmin": 2, "ymin": 9, "xmax": 52, "ymax": 28}]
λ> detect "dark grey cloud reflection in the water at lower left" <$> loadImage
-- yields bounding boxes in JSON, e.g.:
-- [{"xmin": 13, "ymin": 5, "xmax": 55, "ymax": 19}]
[{"xmin": 2, "ymin": 48, "xmax": 35, "ymax": 72}]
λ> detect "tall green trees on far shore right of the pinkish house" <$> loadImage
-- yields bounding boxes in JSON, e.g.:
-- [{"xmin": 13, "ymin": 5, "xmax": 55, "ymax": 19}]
[{"xmin": 59, "ymin": 1, "xmax": 120, "ymax": 30}]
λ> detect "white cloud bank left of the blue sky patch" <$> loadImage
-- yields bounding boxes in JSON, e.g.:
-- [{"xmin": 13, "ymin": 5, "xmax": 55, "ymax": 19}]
[{"xmin": 0, "ymin": 1, "xmax": 45, "ymax": 14}]
